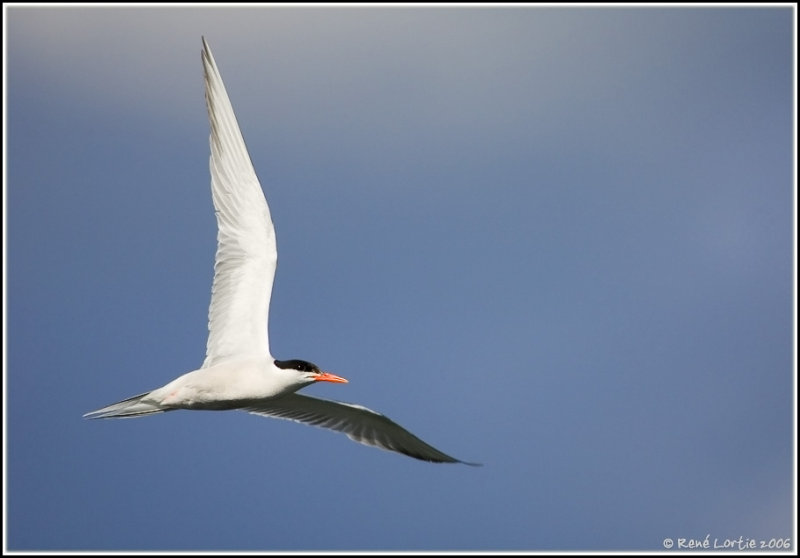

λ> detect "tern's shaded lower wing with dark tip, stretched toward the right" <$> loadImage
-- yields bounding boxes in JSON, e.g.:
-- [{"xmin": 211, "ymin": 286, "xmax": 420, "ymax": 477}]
[{"xmin": 242, "ymin": 393, "xmax": 476, "ymax": 465}]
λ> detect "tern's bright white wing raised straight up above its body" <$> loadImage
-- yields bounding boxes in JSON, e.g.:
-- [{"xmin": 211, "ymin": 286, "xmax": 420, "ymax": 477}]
[{"xmin": 203, "ymin": 38, "xmax": 278, "ymax": 368}]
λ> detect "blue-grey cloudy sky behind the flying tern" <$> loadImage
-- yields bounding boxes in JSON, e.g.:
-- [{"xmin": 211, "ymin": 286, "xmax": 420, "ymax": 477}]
[{"xmin": 4, "ymin": 6, "xmax": 796, "ymax": 550}]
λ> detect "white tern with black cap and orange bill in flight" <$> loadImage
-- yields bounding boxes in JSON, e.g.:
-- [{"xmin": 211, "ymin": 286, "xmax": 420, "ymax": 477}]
[{"xmin": 84, "ymin": 38, "xmax": 475, "ymax": 465}]
